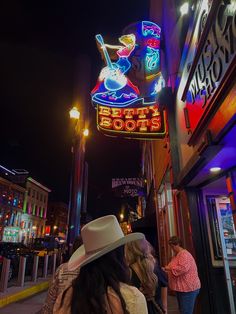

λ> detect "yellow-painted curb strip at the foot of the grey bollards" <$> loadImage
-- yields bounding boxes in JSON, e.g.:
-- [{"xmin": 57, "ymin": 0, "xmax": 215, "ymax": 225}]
[{"xmin": 0, "ymin": 277, "xmax": 51, "ymax": 308}]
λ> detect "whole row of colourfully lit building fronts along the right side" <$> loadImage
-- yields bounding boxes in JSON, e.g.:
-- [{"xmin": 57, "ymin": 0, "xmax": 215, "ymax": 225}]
[{"xmin": 140, "ymin": 0, "xmax": 236, "ymax": 314}]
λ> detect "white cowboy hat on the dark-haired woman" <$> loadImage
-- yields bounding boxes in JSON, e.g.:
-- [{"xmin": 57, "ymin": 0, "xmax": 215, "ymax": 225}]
[{"xmin": 68, "ymin": 215, "xmax": 144, "ymax": 271}]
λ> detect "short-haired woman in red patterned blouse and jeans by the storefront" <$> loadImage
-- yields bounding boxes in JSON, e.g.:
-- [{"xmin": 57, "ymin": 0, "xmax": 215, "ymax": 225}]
[{"xmin": 164, "ymin": 236, "xmax": 201, "ymax": 314}]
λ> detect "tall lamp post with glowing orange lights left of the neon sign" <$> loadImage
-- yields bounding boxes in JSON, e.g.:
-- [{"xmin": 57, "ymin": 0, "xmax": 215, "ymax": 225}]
[{"xmin": 67, "ymin": 107, "xmax": 89, "ymax": 252}]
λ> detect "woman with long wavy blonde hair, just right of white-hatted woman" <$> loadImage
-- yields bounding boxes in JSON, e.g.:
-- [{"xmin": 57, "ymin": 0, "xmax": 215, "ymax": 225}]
[{"xmin": 125, "ymin": 238, "xmax": 166, "ymax": 314}]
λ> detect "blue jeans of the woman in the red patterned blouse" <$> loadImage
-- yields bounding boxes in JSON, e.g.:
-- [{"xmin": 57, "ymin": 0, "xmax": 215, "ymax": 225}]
[{"xmin": 176, "ymin": 289, "xmax": 200, "ymax": 314}]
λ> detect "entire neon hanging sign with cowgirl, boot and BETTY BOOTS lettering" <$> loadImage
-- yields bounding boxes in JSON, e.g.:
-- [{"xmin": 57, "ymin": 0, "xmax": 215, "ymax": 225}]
[{"xmin": 91, "ymin": 21, "xmax": 166, "ymax": 139}]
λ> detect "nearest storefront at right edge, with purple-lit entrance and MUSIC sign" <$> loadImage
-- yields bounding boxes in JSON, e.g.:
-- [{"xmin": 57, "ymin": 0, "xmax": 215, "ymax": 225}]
[{"xmin": 172, "ymin": 1, "xmax": 236, "ymax": 314}]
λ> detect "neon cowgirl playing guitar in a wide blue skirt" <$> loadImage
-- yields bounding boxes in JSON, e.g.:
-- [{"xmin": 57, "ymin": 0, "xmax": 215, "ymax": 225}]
[{"xmin": 91, "ymin": 34, "xmax": 140, "ymax": 107}]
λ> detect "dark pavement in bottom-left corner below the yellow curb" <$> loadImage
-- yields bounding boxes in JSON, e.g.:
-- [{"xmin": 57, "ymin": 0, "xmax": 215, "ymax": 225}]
[{"xmin": 0, "ymin": 292, "xmax": 47, "ymax": 314}]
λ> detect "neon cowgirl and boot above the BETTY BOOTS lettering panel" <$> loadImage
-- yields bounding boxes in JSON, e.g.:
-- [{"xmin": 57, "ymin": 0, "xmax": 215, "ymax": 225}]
[{"xmin": 91, "ymin": 21, "xmax": 164, "ymax": 107}]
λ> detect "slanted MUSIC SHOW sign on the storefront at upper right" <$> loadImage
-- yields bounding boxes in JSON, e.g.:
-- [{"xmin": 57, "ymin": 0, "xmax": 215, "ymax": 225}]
[{"xmin": 182, "ymin": 0, "xmax": 236, "ymax": 144}]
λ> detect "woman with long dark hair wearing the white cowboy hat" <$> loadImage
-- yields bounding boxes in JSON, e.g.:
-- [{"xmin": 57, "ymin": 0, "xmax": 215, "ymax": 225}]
[{"xmin": 53, "ymin": 215, "xmax": 148, "ymax": 314}]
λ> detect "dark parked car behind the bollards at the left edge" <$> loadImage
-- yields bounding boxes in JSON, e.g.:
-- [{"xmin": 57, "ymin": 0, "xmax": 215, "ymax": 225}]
[{"xmin": 0, "ymin": 242, "xmax": 35, "ymax": 279}]
